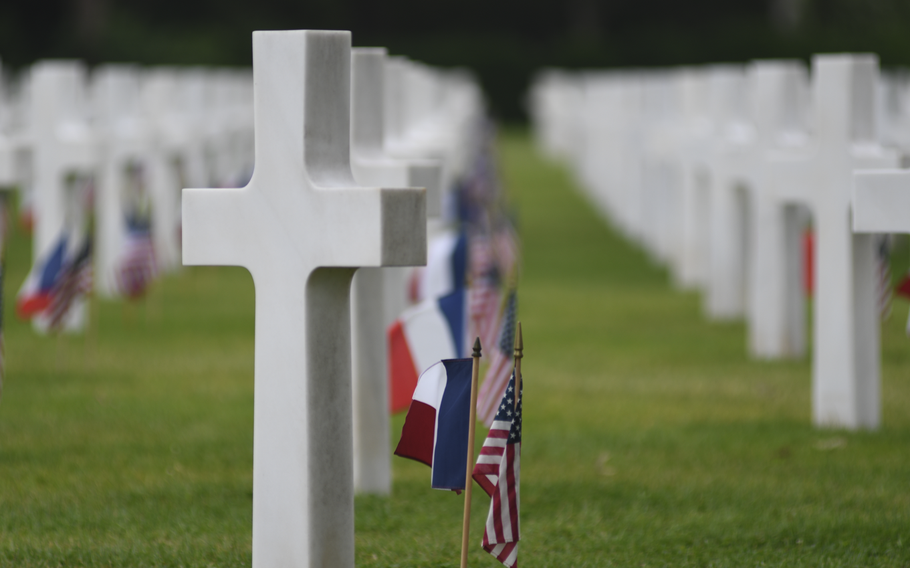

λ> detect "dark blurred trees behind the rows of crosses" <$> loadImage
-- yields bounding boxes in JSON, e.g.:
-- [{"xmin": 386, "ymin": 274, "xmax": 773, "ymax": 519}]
[{"xmin": 0, "ymin": 0, "xmax": 910, "ymax": 121}]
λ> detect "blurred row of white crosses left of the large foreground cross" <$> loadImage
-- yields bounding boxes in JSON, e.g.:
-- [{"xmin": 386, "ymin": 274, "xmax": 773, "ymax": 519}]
[{"xmin": 0, "ymin": 61, "xmax": 252, "ymax": 310}]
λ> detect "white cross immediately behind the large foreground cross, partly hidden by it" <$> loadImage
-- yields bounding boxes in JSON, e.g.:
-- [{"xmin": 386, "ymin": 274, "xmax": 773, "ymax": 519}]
[{"xmin": 351, "ymin": 48, "xmax": 442, "ymax": 494}]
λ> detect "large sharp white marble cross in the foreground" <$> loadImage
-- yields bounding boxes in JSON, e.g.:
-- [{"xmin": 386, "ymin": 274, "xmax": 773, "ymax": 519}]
[{"xmin": 183, "ymin": 30, "xmax": 426, "ymax": 568}]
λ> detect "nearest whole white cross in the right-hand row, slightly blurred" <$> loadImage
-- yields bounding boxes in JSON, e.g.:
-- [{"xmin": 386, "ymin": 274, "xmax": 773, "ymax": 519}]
[{"xmin": 756, "ymin": 55, "xmax": 898, "ymax": 428}]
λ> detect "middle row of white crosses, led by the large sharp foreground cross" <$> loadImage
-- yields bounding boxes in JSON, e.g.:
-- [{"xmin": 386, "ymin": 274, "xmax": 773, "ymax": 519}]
[{"xmin": 183, "ymin": 31, "xmax": 480, "ymax": 567}]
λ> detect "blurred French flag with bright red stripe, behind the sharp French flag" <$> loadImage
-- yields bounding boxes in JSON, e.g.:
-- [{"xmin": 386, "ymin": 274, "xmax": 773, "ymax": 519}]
[{"xmin": 387, "ymin": 288, "xmax": 468, "ymax": 413}]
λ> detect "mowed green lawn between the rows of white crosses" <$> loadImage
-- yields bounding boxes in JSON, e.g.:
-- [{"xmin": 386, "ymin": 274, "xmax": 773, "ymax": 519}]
[{"xmin": 0, "ymin": 133, "xmax": 910, "ymax": 568}]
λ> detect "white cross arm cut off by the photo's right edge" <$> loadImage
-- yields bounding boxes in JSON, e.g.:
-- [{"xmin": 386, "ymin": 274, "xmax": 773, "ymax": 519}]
[{"xmin": 853, "ymin": 169, "xmax": 910, "ymax": 233}]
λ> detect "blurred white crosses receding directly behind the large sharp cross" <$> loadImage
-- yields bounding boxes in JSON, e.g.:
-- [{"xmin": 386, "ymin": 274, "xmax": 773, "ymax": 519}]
[{"xmin": 351, "ymin": 48, "xmax": 482, "ymax": 494}]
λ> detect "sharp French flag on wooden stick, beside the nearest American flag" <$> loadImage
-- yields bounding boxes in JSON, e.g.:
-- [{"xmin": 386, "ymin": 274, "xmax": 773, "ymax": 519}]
[{"xmin": 395, "ymin": 359, "xmax": 473, "ymax": 491}]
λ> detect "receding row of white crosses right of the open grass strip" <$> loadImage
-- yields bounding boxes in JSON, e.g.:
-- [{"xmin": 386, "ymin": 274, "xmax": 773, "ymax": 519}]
[{"xmin": 532, "ymin": 55, "xmax": 910, "ymax": 428}]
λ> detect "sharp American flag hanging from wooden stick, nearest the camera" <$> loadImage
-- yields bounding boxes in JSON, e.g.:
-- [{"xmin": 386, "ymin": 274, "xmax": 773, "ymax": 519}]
[{"xmin": 472, "ymin": 373, "xmax": 523, "ymax": 568}]
